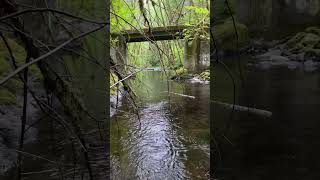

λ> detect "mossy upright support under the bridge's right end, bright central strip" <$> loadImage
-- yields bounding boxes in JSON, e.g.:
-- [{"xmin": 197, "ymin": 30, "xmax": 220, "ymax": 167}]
[{"xmin": 184, "ymin": 37, "xmax": 210, "ymax": 72}]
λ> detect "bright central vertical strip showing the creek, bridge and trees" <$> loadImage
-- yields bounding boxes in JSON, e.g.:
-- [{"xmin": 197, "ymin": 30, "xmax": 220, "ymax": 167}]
[{"xmin": 110, "ymin": 0, "xmax": 210, "ymax": 179}]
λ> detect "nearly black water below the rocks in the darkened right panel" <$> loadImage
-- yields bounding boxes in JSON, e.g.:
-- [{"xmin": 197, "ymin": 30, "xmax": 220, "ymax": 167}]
[{"xmin": 212, "ymin": 57, "xmax": 320, "ymax": 180}]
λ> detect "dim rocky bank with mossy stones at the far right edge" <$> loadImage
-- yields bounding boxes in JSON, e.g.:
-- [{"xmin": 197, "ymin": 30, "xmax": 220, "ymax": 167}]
[{"xmin": 242, "ymin": 27, "xmax": 320, "ymax": 71}]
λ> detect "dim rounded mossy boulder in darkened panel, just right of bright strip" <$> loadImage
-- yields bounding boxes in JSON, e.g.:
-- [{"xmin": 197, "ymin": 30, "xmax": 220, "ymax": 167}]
[{"xmin": 213, "ymin": 20, "xmax": 249, "ymax": 51}]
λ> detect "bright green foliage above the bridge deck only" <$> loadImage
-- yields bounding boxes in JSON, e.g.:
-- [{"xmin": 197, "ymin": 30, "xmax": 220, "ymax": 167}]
[{"xmin": 111, "ymin": 0, "xmax": 209, "ymax": 32}]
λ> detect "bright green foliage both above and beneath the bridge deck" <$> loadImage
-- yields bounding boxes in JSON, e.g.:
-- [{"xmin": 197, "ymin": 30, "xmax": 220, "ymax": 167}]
[{"xmin": 111, "ymin": 0, "xmax": 210, "ymax": 88}]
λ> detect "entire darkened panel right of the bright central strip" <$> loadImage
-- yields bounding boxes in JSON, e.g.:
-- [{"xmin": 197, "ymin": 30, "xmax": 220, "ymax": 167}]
[{"xmin": 210, "ymin": 0, "xmax": 320, "ymax": 179}]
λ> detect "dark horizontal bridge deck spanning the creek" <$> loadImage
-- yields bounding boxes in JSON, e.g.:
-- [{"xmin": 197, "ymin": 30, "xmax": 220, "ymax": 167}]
[{"xmin": 111, "ymin": 26, "xmax": 188, "ymax": 43}]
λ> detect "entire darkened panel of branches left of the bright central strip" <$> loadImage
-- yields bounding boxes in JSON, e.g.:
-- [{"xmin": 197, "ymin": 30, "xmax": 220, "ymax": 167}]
[{"xmin": 0, "ymin": 0, "xmax": 109, "ymax": 180}]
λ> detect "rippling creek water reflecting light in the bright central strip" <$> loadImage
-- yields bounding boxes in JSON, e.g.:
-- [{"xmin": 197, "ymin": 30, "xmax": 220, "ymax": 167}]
[{"xmin": 111, "ymin": 71, "xmax": 210, "ymax": 180}]
